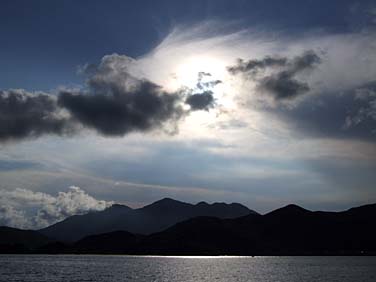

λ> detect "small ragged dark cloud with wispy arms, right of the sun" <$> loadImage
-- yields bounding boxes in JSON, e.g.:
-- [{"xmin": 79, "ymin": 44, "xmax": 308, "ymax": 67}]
[{"xmin": 228, "ymin": 51, "xmax": 321, "ymax": 100}]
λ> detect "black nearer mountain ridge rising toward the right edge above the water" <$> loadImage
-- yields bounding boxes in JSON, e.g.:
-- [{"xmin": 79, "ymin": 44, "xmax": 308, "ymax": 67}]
[{"xmin": 60, "ymin": 205, "xmax": 376, "ymax": 255}]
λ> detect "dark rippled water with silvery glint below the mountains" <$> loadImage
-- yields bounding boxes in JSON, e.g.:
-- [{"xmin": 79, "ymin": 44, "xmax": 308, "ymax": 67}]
[{"xmin": 0, "ymin": 255, "xmax": 376, "ymax": 282}]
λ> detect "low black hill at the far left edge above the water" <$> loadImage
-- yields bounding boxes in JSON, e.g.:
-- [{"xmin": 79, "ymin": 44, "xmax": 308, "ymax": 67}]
[{"xmin": 0, "ymin": 226, "xmax": 50, "ymax": 253}]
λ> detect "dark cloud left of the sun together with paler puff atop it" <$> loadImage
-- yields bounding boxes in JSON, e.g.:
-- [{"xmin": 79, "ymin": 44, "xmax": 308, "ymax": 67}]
[{"xmin": 58, "ymin": 54, "xmax": 191, "ymax": 136}]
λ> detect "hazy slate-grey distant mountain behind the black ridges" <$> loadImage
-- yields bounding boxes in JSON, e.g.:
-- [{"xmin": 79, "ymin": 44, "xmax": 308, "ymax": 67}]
[{"xmin": 39, "ymin": 198, "xmax": 257, "ymax": 242}]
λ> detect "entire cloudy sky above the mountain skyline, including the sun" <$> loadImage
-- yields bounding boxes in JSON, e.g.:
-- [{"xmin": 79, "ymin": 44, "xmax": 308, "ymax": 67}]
[{"xmin": 0, "ymin": 0, "xmax": 376, "ymax": 229}]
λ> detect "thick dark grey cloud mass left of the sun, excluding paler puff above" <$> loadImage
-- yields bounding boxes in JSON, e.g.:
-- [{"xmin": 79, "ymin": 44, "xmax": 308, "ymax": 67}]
[{"xmin": 58, "ymin": 81, "xmax": 183, "ymax": 136}]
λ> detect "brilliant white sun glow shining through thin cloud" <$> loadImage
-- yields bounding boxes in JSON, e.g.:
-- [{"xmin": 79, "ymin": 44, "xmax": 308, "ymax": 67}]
[{"xmin": 136, "ymin": 25, "xmax": 260, "ymax": 135}]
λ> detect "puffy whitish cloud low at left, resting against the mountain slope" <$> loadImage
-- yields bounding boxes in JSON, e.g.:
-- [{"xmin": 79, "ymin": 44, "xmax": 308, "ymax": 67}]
[{"xmin": 0, "ymin": 186, "xmax": 113, "ymax": 229}]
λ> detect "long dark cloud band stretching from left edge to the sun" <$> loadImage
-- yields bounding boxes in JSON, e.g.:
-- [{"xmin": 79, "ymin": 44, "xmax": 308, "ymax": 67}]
[{"xmin": 0, "ymin": 84, "xmax": 186, "ymax": 142}]
